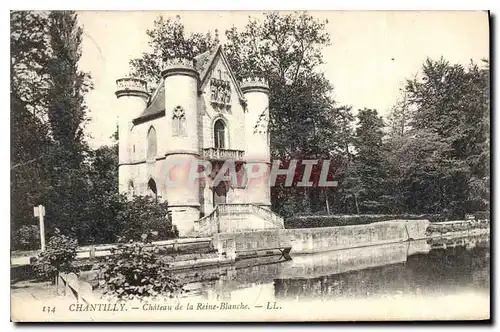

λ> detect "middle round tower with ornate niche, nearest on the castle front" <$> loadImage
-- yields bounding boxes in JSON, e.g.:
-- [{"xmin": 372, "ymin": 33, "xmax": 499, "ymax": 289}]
[{"xmin": 161, "ymin": 58, "xmax": 201, "ymax": 236}]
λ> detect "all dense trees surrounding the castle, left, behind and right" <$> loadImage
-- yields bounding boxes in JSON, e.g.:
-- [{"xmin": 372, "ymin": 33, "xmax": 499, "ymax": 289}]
[{"xmin": 10, "ymin": 11, "xmax": 490, "ymax": 249}]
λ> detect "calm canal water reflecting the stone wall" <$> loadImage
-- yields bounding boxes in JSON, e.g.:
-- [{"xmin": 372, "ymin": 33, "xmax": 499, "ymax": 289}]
[{"xmin": 180, "ymin": 236, "xmax": 490, "ymax": 320}]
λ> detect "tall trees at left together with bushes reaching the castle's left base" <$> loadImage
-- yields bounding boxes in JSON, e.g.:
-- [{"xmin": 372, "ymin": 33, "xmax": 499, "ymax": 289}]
[{"xmin": 11, "ymin": 11, "xmax": 175, "ymax": 250}]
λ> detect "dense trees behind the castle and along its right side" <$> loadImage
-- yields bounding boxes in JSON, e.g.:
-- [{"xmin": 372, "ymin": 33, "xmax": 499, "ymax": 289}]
[{"xmin": 131, "ymin": 12, "xmax": 490, "ymax": 218}]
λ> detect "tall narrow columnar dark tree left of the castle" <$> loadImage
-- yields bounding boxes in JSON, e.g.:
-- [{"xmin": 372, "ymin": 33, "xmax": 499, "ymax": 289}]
[{"xmin": 45, "ymin": 11, "xmax": 92, "ymax": 233}]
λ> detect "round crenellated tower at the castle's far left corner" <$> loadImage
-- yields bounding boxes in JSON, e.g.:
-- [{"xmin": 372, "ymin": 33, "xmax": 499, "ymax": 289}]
[{"xmin": 115, "ymin": 78, "xmax": 149, "ymax": 193}]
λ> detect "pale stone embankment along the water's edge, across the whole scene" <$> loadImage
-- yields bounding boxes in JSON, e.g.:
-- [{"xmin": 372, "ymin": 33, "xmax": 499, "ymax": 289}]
[{"xmin": 11, "ymin": 220, "xmax": 489, "ymax": 269}]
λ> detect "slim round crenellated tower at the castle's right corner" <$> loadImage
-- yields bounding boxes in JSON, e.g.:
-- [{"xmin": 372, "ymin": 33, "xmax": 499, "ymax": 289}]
[{"xmin": 241, "ymin": 77, "xmax": 271, "ymax": 207}]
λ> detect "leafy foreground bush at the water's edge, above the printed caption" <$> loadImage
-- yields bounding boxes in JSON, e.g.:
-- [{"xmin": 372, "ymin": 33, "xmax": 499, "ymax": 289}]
[{"xmin": 96, "ymin": 236, "xmax": 182, "ymax": 300}]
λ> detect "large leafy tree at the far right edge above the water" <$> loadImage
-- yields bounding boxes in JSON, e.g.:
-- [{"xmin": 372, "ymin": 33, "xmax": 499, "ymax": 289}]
[{"xmin": 406, "ymin": 58, "xmax": 490, "ymax": 217}]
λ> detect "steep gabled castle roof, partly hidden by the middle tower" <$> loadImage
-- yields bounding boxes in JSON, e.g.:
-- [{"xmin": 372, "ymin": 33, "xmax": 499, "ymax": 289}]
[{"xmin": 133, "ymin": 44, "xmax": 244, "ymax": 124}]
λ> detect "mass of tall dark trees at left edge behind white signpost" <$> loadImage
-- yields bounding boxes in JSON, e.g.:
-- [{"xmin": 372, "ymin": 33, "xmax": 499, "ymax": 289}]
[{"xmin": 11, "ymin": 11, "xmax": 93, "ymax": 245}]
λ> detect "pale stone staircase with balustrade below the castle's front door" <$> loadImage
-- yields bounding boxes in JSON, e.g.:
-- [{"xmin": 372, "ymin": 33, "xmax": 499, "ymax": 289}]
[{"xmin": 195, "ymin": 204, "xmax": 284, "ymax": 236}]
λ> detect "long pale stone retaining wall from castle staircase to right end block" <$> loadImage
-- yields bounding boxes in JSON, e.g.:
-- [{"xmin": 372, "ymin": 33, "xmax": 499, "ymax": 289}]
[{"xmin": 213, "ymin": 220, "xmax": 429, "ymax": 256}]
